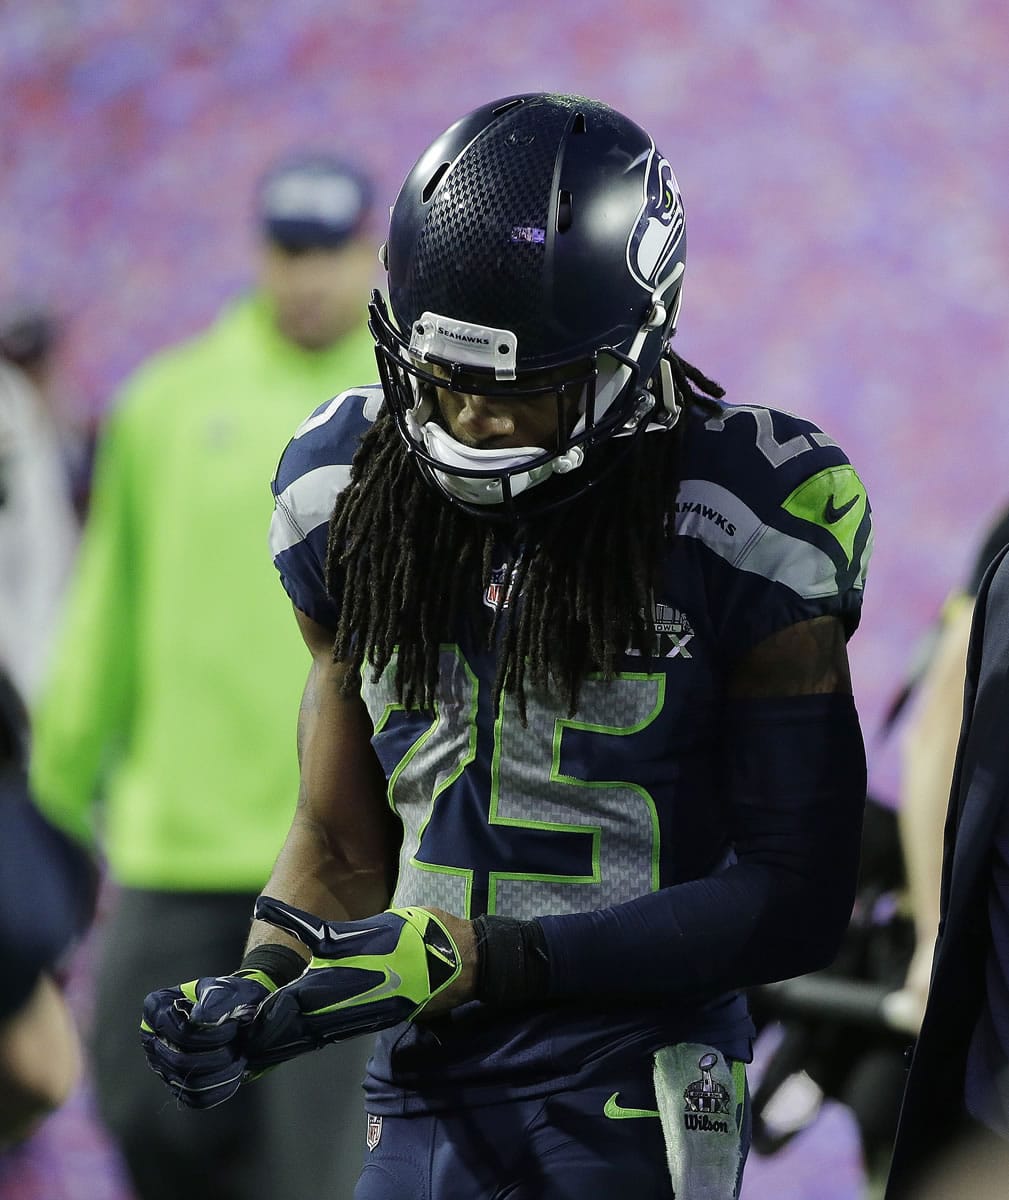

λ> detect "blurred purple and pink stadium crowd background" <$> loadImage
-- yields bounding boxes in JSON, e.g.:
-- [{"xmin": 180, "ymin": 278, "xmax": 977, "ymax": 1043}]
[{"xmin": 0, "ymin": 0, "xmax": 1009, "ymax": 1200}]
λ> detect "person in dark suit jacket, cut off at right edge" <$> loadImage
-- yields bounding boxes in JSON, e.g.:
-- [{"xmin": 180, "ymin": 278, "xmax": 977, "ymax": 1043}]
[{"xmin": 887, "ymin": 548, "xmax": 1009, "ymax": 1200}]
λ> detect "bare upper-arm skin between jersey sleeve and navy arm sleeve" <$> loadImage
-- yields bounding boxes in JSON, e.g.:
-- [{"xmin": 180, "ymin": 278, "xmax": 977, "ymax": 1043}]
[{"xmin": 728, "ymin": 617, "xmax": 852, "ymax": 698}]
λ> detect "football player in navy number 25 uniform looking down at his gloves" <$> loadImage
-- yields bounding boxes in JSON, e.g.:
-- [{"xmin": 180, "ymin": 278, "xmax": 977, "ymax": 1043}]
[{"xmin": 142, "ymin": 94, "xmax": 871, "ymax": 1200}]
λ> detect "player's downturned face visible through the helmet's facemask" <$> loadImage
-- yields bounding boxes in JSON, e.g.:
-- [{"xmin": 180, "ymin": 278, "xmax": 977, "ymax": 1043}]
[{"xmin": 426, "ymin": 365, "xmax": 579, "ymax": 450}]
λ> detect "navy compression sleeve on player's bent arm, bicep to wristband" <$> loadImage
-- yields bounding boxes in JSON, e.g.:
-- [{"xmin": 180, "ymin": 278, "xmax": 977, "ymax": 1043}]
[{"xmin": 539, "ymin": 695, "xmax": 866, "ymax": 998}]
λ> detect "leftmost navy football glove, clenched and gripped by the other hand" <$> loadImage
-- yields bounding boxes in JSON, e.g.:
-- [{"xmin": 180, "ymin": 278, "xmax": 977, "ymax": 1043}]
[{"xmin": 140, "ymin": 971, "xmax": 276, "ymax": 1109}]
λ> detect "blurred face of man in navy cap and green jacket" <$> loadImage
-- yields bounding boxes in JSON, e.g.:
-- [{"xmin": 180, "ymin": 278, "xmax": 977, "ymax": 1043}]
[{"xmin": 259, "ymin": 239, "xmax": 377, "ymax": 350}]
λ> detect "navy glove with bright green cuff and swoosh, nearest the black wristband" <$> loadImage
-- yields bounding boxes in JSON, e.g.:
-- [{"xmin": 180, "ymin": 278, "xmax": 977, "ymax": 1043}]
[{"xmin": 247, "ymin": 896, "xmax": 462, "ymax": 1069}]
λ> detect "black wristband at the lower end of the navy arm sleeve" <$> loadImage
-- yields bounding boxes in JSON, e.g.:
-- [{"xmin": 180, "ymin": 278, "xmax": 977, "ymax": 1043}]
[{"xmin": 473, "ymin": 916, "xmax": 549, "ymax": 1008}]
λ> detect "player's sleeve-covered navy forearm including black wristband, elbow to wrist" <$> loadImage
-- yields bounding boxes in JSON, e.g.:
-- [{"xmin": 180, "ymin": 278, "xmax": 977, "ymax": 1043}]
[{"xmin": 467, "ymin": 838, "xmax": 857, "ymax": 1007}]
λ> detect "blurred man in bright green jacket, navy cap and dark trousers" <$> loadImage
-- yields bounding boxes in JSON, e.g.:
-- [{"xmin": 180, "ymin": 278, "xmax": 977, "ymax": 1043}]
[{"xmin": 32, "ymin": 155, "xmax": 377, "ymax": 1200}]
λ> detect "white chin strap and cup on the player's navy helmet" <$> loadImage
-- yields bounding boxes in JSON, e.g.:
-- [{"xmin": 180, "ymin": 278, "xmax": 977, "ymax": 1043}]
[{"xmin": 407, "ymin": 413, "xmax": 585, "ymax": 504}]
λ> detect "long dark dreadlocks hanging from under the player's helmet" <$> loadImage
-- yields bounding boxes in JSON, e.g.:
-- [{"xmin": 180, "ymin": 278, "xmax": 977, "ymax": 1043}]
[{"xmin": 326, "ymin": 350, "xmax": 725, "ymax": 720}]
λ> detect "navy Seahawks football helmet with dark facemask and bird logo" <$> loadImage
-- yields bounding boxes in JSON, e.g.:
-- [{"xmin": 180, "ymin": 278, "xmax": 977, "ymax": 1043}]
[{"xmin": 370, "ymin": 92, "xmax": 686, "ymax": 516}]
